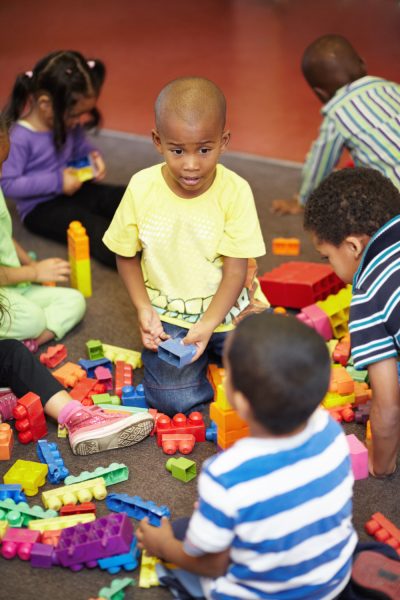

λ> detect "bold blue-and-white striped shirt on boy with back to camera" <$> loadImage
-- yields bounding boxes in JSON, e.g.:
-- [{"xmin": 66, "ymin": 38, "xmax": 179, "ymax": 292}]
[{"xmin": 184, "ymin": 409, "xmax": 357, "ymax": 600}]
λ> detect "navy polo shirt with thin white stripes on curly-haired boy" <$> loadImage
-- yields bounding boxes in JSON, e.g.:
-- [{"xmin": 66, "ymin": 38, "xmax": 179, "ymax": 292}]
[{"xmin": 349, "ymin": 213, "xmax": 400, "ymax": 369}]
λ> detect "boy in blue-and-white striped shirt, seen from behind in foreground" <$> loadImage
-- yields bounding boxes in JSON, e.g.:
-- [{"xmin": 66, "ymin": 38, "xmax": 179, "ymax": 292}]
[{"xmin": 137, "ymin": 312, "xmax": 357, "ymax": 600}]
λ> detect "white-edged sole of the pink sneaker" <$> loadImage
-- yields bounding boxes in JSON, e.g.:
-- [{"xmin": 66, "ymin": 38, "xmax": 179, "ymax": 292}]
[{"xmin": 69, "ymin": 413, "xmax": 154, "ymax": 456}]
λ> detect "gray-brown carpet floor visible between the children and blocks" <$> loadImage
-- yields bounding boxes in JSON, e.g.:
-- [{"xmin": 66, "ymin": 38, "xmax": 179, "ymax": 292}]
[{"xmin": 0, "ymin": 132, "xmax": 400, "ymax": 600}]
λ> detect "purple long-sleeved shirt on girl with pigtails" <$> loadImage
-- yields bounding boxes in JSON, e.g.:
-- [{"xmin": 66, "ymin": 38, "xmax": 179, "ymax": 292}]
[{"xmin": 1, "ymin": 123, "xmax": 94, "ymax": 220}]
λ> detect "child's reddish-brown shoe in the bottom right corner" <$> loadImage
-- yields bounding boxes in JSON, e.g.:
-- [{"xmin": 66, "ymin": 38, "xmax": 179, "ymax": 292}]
[{"xmin": 351, "ymin": 550, "xmax": 400, "ymax": 600}]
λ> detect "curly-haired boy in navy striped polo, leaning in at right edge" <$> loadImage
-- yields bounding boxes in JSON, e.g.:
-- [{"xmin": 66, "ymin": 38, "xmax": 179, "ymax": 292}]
[{"xmin": 304, "ymin": 168, "xmax": 400, "ymax": 476}]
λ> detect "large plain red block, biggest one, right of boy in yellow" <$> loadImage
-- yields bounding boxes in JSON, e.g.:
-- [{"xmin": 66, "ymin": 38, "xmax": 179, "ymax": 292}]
[{"xmin": 259, "ymin": 262, "xmax": 344, "ymax": 308}]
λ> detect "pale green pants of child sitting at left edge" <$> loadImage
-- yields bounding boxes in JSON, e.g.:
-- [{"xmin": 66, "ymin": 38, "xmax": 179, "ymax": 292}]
[{"xmin": 0, "ymin": 284, "xmax": 86, "ymax": 340}]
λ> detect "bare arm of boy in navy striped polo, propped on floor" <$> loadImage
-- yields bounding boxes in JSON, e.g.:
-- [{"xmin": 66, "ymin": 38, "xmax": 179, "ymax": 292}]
[{"xmin": 368, "ymin": 358, "xmax": 400, "ymax": 477}]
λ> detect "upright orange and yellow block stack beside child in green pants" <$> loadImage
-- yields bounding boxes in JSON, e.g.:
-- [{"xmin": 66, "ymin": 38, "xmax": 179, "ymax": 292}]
[{"xmin": 67, "ymin": 221, "xmax": 92, "ymax": 298}]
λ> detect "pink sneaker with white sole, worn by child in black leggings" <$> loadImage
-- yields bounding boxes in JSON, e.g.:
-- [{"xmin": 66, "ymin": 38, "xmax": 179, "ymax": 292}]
[{"xmin": 58, "ymin": 401, "xmax": 154, "ymax": 455}]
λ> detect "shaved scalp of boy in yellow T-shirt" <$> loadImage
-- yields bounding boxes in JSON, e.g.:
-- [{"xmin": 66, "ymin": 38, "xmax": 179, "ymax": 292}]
[{"xmin": 154, "ymin": 77, "xmax": 226, "ymax": 131}]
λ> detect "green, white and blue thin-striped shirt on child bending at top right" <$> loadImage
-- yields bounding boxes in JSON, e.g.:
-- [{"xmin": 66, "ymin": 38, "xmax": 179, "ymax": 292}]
[{"xmin": 299, "ymin": 77, "xmax": 400, "ymax": 204}]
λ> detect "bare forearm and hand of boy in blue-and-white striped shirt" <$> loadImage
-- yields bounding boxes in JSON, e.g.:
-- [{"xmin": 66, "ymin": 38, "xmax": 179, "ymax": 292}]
[{"xmin": 136, "ymin": 518, "xmax": 229, "ymax": 578}]
